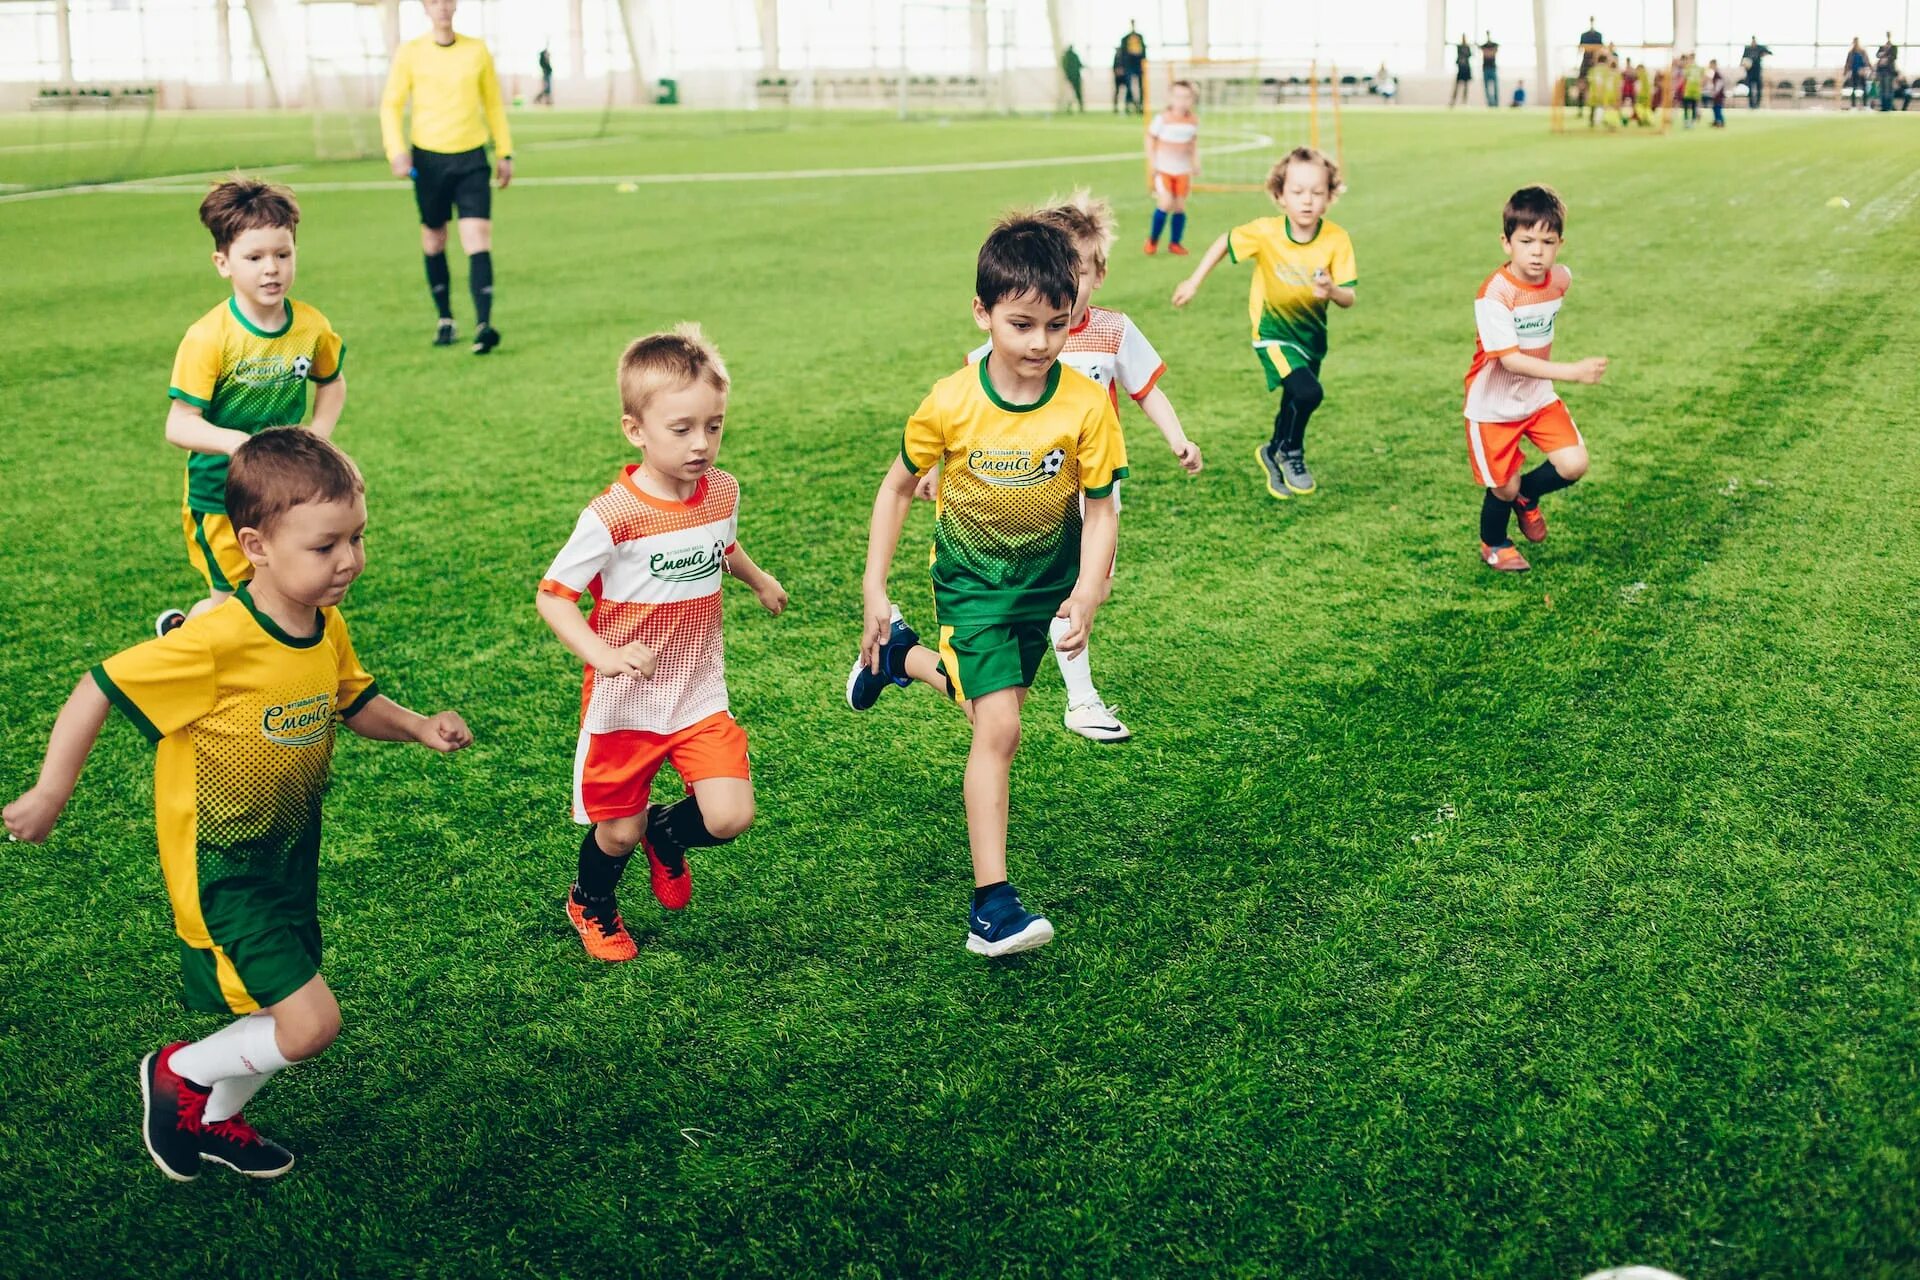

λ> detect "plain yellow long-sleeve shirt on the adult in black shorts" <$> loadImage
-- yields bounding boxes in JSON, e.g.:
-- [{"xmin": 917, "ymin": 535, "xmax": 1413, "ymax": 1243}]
[{"xmin": 380, "ymin": 33, "xmax": 513, "ymax": 159}]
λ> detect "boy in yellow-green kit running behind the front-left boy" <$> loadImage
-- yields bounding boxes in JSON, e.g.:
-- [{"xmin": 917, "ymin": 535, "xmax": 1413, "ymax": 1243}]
[{"xmin": 154, "ymin": 178, "xmax": 348, "ymax": 635}]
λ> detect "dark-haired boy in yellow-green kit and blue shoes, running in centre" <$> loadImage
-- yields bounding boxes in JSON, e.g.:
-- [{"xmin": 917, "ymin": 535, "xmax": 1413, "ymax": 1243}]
[{"xmin": 847, "ymin": 217, "xmax": 1127, "ymax": 956}]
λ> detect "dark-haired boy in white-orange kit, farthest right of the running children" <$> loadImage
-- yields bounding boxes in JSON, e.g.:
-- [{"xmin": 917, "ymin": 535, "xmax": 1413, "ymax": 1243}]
[{"xmin": 1467, "ymin": 186, "xmax": 1607, "ymax": 574}]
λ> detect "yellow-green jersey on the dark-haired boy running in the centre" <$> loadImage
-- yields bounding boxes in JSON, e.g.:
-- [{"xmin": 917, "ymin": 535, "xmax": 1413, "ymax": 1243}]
[{"xmin": 900, "ymin": 361, "xmax": 1127, "ymax": 626}]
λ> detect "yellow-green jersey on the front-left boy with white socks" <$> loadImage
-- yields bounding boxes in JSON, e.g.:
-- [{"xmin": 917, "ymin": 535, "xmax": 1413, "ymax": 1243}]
[{"xmin": 92, "ymin": 585, "xmax": 378, "ymax": 1013}]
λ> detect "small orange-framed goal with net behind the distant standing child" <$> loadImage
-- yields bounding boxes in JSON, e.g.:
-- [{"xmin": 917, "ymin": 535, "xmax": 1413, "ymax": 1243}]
[{"xmin": 1146, "ymin": 58, "xmax": 1346, "ymax": 192}]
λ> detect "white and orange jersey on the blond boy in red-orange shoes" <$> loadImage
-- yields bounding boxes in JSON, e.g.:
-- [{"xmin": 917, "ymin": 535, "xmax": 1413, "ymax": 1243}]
[{"xmin": 540, "ymin": 466, "xmax": 739, "ymax": 736}]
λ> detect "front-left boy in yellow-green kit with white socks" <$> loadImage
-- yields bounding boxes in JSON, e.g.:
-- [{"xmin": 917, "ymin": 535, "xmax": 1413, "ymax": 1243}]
[{"xmin": 0, "ymin": 428, "xmax": 472, "ymax": 1182}]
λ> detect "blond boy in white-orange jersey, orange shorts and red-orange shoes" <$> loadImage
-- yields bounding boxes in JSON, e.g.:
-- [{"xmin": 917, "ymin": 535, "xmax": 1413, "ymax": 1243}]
[{"xmin": 536, "ymin": 324, "xmax": 787, "ymax": 961}]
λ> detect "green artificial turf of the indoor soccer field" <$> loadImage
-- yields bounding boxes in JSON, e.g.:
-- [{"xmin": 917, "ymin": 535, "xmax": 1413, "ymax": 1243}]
[{"xmin": 0, "ymin": 111, "xmax": 1920, "ymax": 1280}]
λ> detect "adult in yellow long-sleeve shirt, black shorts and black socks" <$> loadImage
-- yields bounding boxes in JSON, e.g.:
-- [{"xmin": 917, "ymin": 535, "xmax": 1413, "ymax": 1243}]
[{"xmin": 380, "ymin": 0, "xmax": 513, "ymax": 355}]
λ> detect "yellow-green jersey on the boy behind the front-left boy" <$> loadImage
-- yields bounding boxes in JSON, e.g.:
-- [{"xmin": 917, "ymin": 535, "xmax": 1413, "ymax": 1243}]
[{"xmin": 167, "ymin": 297, "xmax": 348, "ymax": 512}]
